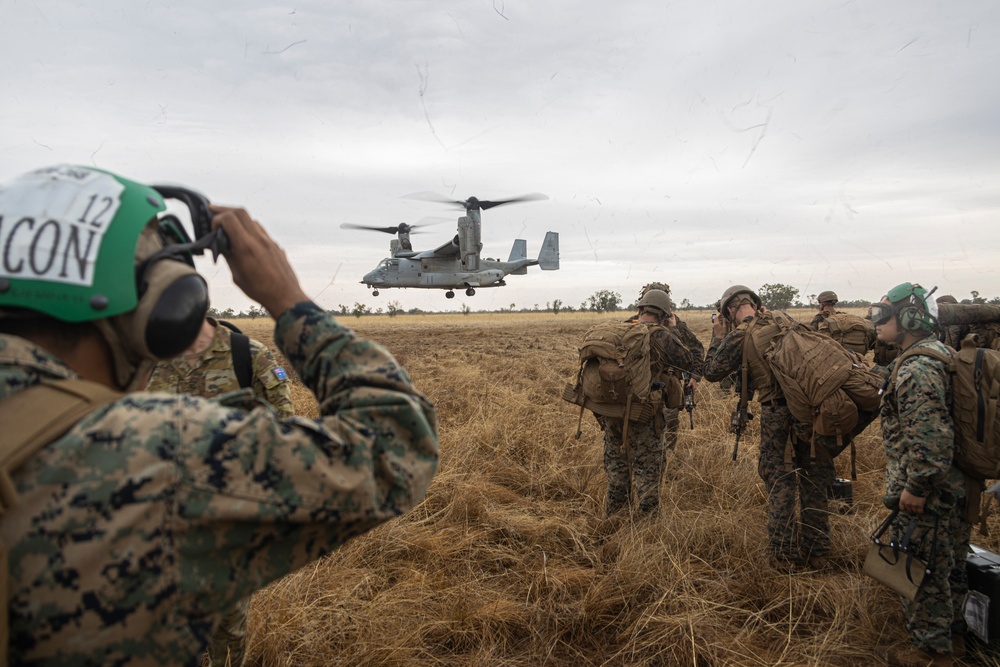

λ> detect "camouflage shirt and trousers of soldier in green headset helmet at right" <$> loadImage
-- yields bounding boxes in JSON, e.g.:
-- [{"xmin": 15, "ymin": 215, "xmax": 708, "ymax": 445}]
[{"xmin": 881, "ymin": 336, "xmax": 971, "ymax": 654}]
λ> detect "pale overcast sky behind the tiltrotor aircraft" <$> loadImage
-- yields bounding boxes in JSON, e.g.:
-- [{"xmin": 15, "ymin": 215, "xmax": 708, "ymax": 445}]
[{"xmin": 0, "ymin": 0, "xmax": 1000, "ymax": 310}]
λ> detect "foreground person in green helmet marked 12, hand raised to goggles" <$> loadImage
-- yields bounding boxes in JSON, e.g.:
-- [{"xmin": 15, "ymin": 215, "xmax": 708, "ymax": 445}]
[{"xmin": 0, "ymin": 165, "xmax": 438, "ymax": 667}]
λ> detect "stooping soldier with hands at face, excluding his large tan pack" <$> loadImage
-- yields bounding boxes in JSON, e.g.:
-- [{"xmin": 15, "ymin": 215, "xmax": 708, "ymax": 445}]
[{"xmin": 702, "ymin": 285, "xmax": 835, "ymax": 571}]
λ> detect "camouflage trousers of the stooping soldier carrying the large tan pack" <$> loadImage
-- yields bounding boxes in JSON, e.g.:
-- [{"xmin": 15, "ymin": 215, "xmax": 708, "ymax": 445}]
[{"xmin": 757, "ymin": 405, "xmax": 835, "ymax": 561}]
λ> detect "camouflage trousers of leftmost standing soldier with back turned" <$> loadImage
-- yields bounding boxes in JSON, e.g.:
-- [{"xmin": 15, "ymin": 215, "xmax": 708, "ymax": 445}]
[{"xmin": 604, "ymin": 418, "xmax": 663, "ymax": 516}]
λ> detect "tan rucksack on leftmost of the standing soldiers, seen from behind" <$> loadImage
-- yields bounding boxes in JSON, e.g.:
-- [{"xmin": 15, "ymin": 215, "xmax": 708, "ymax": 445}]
[{"xmin": 563, "ymin": 321, "xmax": 662, "ymax": 421}]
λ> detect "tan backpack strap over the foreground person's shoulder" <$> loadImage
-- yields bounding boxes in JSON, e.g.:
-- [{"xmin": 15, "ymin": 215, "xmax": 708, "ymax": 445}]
[{"xmin": 0, "ymin": 380, "xmax": 122, "ymax": 667}]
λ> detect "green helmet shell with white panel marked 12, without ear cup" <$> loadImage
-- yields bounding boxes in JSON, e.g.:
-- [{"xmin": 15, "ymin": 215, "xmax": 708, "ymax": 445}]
[{"xmin": 0, "ymin": 165, "xmax": 166, "ymax": 322}]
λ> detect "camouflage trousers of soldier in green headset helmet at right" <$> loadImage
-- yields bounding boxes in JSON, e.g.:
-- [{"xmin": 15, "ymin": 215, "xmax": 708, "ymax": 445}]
[{"xmin": 891, "ymin": 502, "xmax": 972, "ymax": 653}]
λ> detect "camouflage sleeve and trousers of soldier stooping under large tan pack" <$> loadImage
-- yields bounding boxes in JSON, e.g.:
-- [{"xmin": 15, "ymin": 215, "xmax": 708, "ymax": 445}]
[{"xmin": 702, "ymin": 318, "xmax": 835, "ymax": 563}]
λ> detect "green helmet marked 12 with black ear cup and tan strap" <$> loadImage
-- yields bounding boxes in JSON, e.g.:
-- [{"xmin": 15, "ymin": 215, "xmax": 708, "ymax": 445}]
[{"xmin": 0, "ymin": 165, "xmax": 208, "ymax": 389}]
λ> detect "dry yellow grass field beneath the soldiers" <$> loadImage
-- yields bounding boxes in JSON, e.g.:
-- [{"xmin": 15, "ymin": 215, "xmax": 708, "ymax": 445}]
[{"xmin": 225, "ymin": 311, "xmax": 1000, "ymax": 667}]
